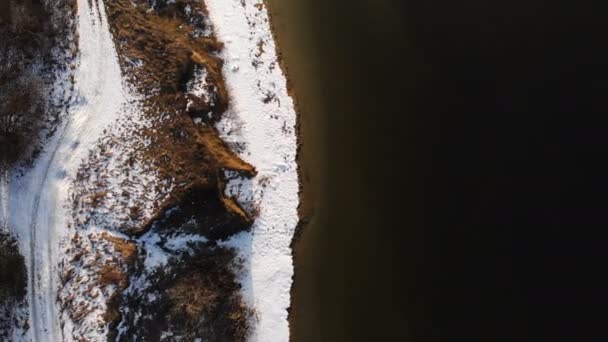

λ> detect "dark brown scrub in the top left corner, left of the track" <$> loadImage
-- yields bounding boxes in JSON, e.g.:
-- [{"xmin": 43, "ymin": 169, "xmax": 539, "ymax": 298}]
[{"xmin": 0, "ymin": 0, "xmax": 74, "ymax": 165}]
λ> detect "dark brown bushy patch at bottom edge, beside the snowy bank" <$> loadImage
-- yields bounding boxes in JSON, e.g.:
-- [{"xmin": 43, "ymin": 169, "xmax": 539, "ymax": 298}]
[{"xmin": 123, "ymin": 244, "xmax": 254, "ymax": 342}]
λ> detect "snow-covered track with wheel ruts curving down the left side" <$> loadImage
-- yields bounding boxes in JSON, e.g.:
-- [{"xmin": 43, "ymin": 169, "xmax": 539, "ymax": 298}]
[{"xmin": 2, "ymin": 0, "xmax": 129, "ymax": 342}]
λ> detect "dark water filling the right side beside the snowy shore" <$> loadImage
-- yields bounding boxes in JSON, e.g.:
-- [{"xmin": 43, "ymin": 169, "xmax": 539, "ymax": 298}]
[{"xmin": 269, "ymin": 0, "xmax": 608, "ymax": 342}]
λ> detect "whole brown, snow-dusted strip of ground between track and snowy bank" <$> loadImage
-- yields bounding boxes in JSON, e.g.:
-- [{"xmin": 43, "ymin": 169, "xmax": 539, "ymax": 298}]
[{"xmin": 59, "ymin": 0, "xmax": 256, "ymax": 342}]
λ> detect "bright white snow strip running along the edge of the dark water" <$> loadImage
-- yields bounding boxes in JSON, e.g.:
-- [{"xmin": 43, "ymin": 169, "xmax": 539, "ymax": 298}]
[{"xmin": 206, "ymin": 0, "xmax": 299, "ymax": 342}]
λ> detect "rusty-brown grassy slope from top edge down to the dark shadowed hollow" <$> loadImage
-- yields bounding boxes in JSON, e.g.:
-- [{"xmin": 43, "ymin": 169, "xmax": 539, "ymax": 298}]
[{"xmin": 73, "ymin": 0, "xmax": 256, "ymax": 237}]
